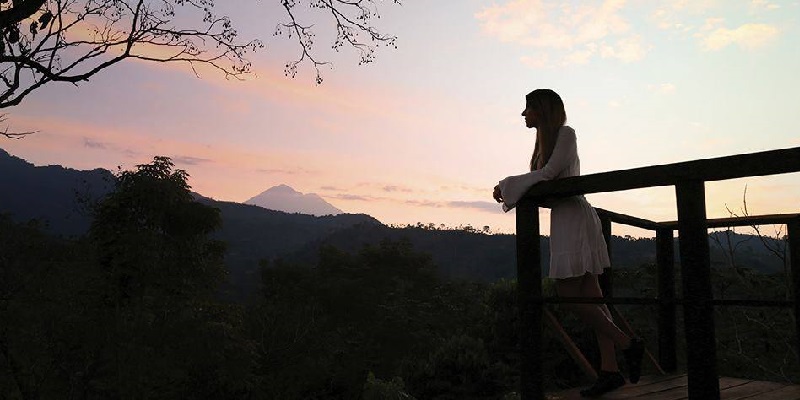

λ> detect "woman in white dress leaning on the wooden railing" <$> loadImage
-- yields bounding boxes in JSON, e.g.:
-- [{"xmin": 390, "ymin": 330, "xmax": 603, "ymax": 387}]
[{"xmin": 493, "ymin": 89, "xmax": 644, "ymax": 397}]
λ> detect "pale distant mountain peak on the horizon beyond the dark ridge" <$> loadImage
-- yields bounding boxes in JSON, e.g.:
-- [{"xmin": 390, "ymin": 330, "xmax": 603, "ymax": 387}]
[{"xmin": 244, "ymin": 185, "xmax": 342, "ymax": 216}]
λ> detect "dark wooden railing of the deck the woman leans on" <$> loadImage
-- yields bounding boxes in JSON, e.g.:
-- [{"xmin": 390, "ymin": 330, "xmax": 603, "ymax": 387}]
[{"xmin": 516, "ymin": 147, "xmax": 800, "ymax": 400}]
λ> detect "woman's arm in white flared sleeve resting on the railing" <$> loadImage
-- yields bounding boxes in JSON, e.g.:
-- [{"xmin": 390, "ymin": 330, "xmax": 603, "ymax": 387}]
[{"xmin": 498, "ymin": 126, "xmax": 578, "ymax": 212}]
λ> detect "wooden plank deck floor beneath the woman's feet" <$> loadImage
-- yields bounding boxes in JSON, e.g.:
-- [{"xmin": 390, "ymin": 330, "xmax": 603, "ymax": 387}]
[{"xmin": 547, "ymin": 375, "xmax": 800, "ymax": 400}]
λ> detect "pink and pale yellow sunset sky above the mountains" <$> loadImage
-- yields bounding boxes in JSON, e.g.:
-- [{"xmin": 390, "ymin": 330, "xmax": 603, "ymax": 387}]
[{"xmin": 0, "ymin": 0, "xmax": 800, "ymax": 236}]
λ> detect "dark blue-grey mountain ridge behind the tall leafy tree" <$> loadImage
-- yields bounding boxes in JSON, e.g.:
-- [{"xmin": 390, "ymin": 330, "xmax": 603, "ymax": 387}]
[{"xmin": 0, "ymin": 149, "xmax": 380, "ymax": 297}]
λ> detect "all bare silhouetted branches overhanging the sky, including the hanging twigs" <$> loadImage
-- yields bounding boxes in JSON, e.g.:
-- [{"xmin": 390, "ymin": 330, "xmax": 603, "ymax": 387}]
[{"xmin": 0, "ymin": 0, "xmax": 400, "ymax": 120}]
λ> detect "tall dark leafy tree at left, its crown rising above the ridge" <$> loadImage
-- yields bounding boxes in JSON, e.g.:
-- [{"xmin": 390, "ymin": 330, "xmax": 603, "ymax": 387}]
[{"xmin": 89, "ymin": 157, "xmax": 258, "ymax": 398}]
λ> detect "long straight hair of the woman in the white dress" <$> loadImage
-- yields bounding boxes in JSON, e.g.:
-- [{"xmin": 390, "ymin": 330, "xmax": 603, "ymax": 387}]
[{"xmin": 525, "ymin": 89, "xmax": 567, "ymax": 171}]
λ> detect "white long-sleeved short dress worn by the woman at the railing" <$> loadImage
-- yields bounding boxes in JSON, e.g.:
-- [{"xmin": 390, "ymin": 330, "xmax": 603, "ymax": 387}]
[{"xmin": 500, "ymin": 126, "xmax": 611, "ymax": 279}]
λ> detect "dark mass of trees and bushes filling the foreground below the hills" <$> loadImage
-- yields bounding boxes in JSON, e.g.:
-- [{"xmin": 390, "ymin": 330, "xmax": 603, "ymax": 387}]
[{"xmin": 0, "ymin": 158, "xmax": 800, "ymax": 400}]
